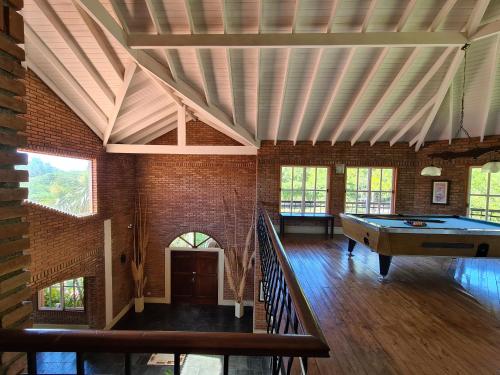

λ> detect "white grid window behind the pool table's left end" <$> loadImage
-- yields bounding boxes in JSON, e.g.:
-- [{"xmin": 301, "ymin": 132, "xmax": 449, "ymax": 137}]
[{"xmin": 345, "ymin": 168, "xmax": 394, "ymax": 214}]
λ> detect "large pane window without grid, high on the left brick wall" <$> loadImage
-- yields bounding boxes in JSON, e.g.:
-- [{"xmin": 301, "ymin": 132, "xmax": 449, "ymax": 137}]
[{"xmin": 19, "ymin": 152, "xmax": 93, "ymax": 216}]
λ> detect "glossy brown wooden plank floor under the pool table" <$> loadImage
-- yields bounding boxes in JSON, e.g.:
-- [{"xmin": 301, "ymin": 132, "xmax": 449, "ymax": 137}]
[{"xmin": 283, "ymin": 235, "xmax": 500, "ymax": 375}]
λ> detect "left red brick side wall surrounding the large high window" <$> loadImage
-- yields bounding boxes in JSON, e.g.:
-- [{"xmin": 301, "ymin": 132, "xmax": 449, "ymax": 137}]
[{"xmin": 26, "ymin": 71, "xmax": 135, "ymax": 327}]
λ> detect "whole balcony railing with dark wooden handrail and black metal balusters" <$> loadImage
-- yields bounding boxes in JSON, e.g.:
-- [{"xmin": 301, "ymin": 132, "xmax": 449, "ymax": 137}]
[{"xmin": 0, "ymin": 207, "xmax": 330, "ymax": 375}]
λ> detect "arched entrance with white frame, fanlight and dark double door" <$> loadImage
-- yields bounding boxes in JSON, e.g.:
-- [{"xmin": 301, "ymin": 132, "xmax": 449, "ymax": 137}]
[{"xmin": 165, "ymin": 232, "xmax": 224, "ymax": 305}]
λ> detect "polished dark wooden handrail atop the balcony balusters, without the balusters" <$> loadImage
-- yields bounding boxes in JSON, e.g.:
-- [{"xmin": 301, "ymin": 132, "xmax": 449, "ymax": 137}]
[{"xmin": 0, "ymin": 205, "xmax": 330, "ymax": 358}]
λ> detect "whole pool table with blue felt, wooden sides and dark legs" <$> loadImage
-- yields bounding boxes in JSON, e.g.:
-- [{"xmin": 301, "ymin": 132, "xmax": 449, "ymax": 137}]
[{"xmin": 340, "ymin": 214, "xmax": 500, "ymax": 277}]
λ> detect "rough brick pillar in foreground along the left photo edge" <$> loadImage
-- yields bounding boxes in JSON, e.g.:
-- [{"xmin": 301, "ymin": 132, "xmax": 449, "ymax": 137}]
[{"xmin": 0, "ymin": 0, "xmax": 32, "ymax": 374}]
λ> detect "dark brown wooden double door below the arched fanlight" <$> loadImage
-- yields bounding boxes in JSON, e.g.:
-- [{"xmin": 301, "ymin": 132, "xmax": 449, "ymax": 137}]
[{"xmin": 171, "ymin": 251, "xmax": 219, "ymax": 305}]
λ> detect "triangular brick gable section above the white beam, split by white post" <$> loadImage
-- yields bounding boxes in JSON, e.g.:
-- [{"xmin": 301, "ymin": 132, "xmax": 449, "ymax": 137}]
[{"xmin": 149, "ymin": 120, "xmax": 241, "ymax": 146}]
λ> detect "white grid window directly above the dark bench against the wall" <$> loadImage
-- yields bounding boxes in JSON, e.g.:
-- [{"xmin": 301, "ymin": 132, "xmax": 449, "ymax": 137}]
[{"xmin": 280, "ymin": 166, "xmax": 328, "ymax": 214}]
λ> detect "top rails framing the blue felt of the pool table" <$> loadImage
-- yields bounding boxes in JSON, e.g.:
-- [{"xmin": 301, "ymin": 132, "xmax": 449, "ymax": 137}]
[{"xmin": 340, "ymin": 213, "xmax": 500, "ymax": 236}]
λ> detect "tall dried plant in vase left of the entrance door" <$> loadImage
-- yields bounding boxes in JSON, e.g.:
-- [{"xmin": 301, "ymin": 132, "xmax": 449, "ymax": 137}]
[{"xmin": 131, "ymin": 194, "xmax": 149, "ymax": 313}]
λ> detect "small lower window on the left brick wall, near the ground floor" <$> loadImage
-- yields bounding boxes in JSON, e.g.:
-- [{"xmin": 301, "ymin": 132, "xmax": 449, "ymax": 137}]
[{"xmin": 38, "ymin": 277, "xmax": 85, "ymax": 311}]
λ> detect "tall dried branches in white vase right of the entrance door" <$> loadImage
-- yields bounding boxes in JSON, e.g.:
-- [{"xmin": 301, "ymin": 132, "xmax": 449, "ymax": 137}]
[{"xmin": 222, "ymin": 190, "xmax": 255, "ymax": 318}]
